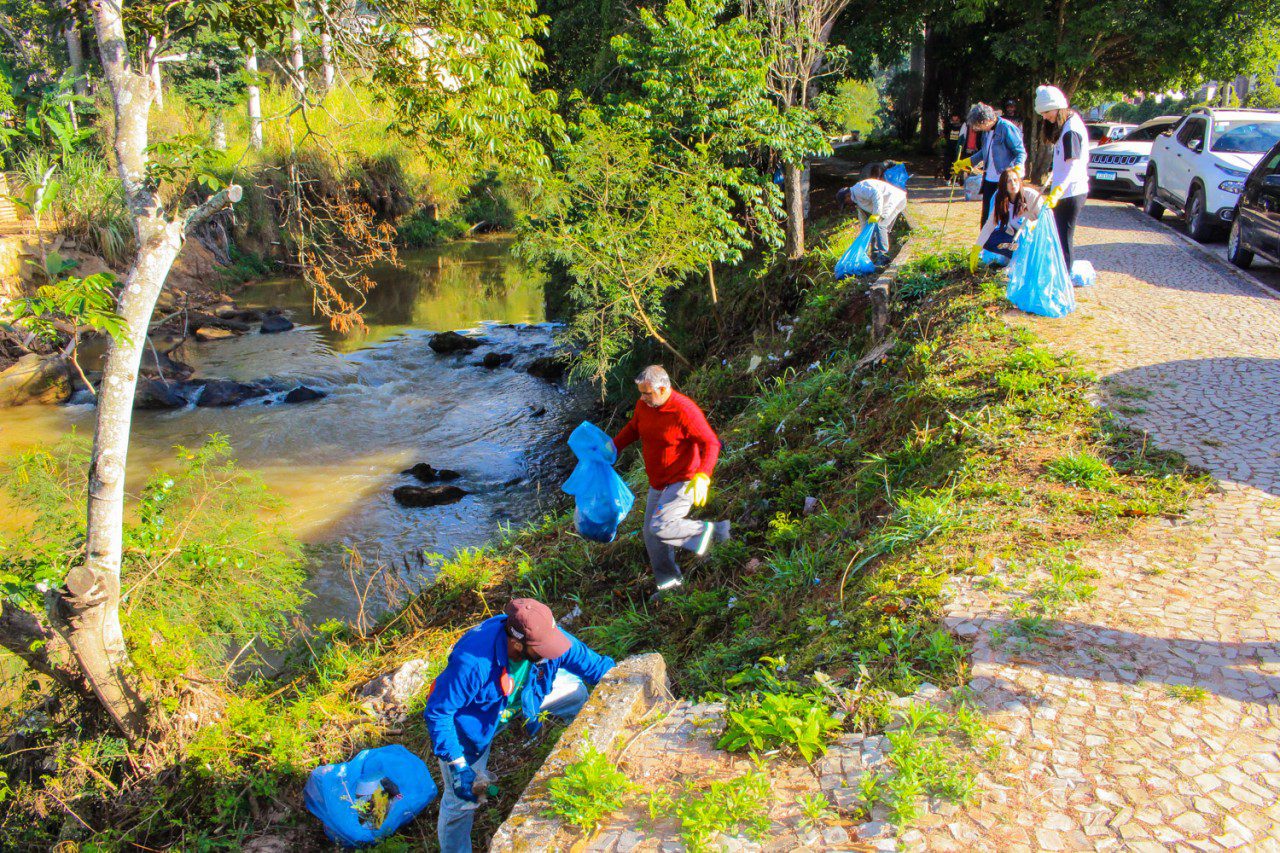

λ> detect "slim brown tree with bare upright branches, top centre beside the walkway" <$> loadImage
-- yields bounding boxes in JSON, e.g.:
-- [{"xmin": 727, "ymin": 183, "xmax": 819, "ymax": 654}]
[{"xmin": 742, "ymin": 0, "xmax": 850, "ymax": 260}]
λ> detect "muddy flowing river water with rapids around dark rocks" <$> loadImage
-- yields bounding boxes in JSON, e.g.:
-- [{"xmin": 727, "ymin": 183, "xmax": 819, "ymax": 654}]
[{"xmin": 0, "ymin": 240, "xmax": 590, "ymax": 621}]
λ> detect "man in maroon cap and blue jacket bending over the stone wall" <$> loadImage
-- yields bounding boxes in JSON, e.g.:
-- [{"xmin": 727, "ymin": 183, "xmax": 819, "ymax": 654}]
[{"xmin": 422, "ymin": 598, "xmax": 613, "ymax": 853}]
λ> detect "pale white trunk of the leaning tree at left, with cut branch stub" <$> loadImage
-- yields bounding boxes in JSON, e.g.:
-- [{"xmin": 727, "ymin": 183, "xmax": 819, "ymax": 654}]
[{"xmin": 58, "ymin": 0, "xmax": 241, "ymax": 740}]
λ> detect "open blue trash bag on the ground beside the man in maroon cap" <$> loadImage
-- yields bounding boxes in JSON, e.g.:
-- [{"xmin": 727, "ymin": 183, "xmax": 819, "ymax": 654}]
[{"xmin": 302, "ymin": 743, "xmax": 438, "ymax": 847}]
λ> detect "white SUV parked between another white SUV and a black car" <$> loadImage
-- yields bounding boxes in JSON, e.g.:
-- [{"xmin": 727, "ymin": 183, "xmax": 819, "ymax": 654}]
[{"xmin": 1142, "ymin": 108, "xmax": 1280, "ymax": 242}]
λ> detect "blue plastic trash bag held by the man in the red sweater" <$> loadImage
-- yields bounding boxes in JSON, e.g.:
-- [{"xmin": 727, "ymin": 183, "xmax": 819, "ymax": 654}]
[{"xmin": 561, "ymin": 421, "xmax": 636, "ymax": 542}]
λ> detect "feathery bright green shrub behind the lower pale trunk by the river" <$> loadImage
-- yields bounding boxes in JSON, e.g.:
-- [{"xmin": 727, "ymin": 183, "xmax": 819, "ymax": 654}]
[{"xmin": 0, "ymin": 435, "xmax": 306, "ymax": 679}]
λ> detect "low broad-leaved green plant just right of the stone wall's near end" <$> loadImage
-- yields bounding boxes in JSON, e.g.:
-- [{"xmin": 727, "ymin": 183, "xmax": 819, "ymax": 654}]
[{"xmin": 716, "ymin": 693, "xmax": 840, "ymax": 761}]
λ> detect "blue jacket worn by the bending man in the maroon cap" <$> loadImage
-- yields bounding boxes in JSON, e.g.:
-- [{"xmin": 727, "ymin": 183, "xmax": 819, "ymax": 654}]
[{"xmin": 422, "ymin": 616, "xmax": 613, "ymax": 765}]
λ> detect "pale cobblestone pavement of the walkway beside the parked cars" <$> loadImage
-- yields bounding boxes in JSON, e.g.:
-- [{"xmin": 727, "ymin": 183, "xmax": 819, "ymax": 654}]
[{"xmin": 904, "ymin": 178, "xmax": 1280, "ymax": 850}]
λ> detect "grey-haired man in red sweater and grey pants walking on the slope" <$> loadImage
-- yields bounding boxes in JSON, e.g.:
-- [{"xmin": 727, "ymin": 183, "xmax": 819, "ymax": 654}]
[{"xmin": 613, "ymin": 365, "xmax": 730, "ymax": 593}]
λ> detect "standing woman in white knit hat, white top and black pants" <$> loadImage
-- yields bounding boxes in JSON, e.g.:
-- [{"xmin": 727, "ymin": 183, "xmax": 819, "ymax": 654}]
[{"xmin": 1036, "ymin": 86, "xmax": 1089, "ymax": 266}]
